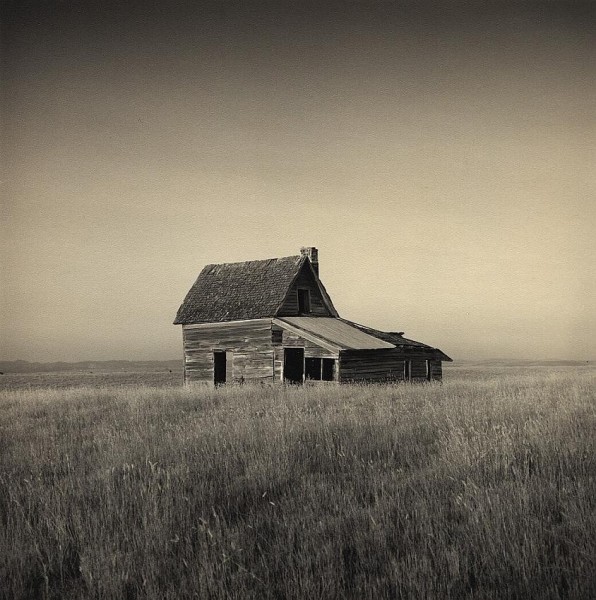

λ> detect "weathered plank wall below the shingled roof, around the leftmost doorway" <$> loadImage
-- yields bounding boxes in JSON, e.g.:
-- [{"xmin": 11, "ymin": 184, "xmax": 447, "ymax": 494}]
[{"xmin": 182, "ymin": 319, "xmax": 274, "ymax": 383}]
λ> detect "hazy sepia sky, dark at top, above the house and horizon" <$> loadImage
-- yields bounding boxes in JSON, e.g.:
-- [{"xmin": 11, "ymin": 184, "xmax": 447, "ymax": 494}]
[{"xmin": 0, "ymin": 0, "xmax": 596, "ymax": 361}]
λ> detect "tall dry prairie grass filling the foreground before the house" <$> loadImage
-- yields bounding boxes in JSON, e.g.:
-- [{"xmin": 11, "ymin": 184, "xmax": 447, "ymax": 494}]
[{"xmin": 0, "ymin": 369, "xmax": 596, "ymax": 599}]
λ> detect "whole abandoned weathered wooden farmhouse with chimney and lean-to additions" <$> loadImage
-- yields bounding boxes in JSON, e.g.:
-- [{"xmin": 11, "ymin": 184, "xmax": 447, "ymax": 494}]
[{"xmin": 174, "ymin": 247, "xmax": 451, "ymax": 385}]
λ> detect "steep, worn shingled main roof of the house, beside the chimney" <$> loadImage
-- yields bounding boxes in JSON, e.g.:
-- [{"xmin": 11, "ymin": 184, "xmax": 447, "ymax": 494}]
[{"xmin": 174, "ymin": 255, "xmax": 338, "ymax": 325}]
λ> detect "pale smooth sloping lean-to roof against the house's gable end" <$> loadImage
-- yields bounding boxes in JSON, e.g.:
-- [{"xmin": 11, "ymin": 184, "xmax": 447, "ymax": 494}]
[{"xmin": 275, "ymin": 317, "xmax": 395, "ymax": 350}]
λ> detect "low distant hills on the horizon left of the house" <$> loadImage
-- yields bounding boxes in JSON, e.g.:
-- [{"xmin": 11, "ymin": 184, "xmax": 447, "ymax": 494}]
[{"xmin": 0, "ymin": 359, "xmax": 182, "ymax": 373}]
